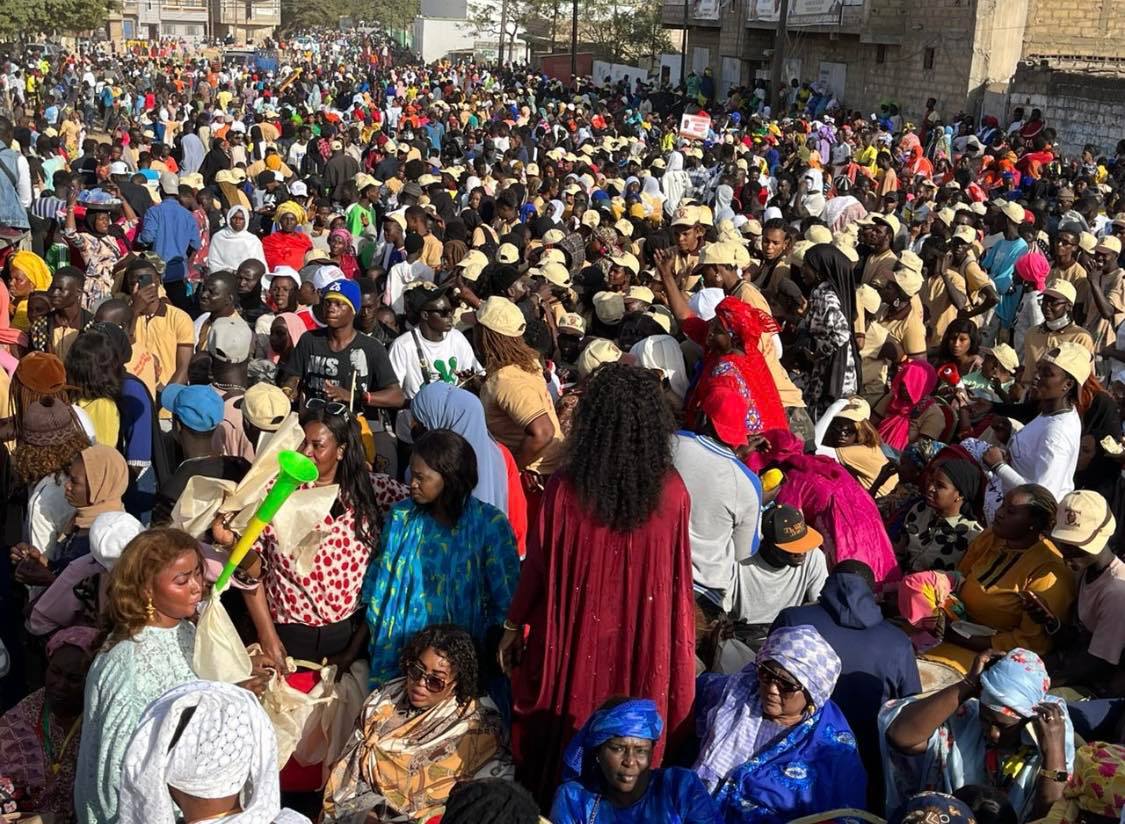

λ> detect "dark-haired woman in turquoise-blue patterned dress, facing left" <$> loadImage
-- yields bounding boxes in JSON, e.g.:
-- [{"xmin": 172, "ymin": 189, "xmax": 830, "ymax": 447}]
[{"xmin": 360, "ymin": 429, "xmax": 520, "ymax": 689}]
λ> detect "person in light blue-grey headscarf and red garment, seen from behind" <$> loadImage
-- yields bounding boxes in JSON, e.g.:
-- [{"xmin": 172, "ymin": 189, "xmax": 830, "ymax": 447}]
[{"xmin": 411, "ymin": 380, "xmax": 528, "ymax": 558}]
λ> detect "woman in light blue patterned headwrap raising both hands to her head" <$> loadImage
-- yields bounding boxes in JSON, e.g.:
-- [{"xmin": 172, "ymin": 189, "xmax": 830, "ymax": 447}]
[{"xmin": 879, "ymin": 648, "xmax": 1074, "ymax": 822}]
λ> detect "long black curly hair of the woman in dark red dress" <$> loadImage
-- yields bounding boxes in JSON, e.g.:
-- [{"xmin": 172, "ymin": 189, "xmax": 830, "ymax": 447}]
[{"xmin": 568, "ymin": 364, "xmax": 676, "ymax": 532}]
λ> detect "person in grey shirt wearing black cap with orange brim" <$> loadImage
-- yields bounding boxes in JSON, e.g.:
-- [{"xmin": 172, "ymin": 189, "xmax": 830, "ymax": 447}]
[{"xmin": 732, "ymin": 505, "xmax": 828, "ymax": 637}]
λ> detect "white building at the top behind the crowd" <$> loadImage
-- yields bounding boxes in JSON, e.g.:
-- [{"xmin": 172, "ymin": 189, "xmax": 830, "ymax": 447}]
[{"xmin": 414, "ymin": 0, "xmax": 527, "ymax": 63}]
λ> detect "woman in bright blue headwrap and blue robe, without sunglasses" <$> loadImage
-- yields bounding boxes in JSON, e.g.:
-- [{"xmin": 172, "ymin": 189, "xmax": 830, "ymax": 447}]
[{"xmin": 550, "ymin": 698, "xmax": 722, "ymax": 824}]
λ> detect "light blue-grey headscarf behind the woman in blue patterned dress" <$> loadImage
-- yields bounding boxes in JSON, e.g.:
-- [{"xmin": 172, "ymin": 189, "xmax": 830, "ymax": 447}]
[{"xmin": 411, "ymin": 380, "xmax": 507, "ymax": 514}]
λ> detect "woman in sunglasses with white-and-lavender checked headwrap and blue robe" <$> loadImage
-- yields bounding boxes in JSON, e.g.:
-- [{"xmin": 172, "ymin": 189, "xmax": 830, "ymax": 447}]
[{"xmin": 695, "ymin": 626, "xmax": 867, "ymax": 824}]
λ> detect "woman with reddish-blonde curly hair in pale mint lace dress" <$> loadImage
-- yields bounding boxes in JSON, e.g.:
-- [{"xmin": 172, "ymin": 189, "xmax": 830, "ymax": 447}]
[{"xmin": 74, "ymin": 529, "xmax": 204, "ymax": 822}]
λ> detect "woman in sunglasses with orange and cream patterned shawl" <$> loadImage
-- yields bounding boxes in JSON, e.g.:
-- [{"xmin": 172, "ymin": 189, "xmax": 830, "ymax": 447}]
[{"xmin": 323, "ymin": 624, "xmax": 514, "ymax": 824}]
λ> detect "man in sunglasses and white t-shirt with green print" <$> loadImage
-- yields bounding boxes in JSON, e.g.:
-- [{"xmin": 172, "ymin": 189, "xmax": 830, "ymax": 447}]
[{"xmin": 387, "ymin": 284, "xmax": 484, "ymax": 444}]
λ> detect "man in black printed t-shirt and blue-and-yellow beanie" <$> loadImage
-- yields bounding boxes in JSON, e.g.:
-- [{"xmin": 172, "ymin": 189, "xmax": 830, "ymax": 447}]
[{"xmin": 279, "ymin": 280, "xmax": 405, "ymax": 476}]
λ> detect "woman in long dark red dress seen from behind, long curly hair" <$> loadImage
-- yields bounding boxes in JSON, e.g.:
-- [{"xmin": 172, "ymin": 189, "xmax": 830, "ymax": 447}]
[{"xmin": 500, "ymin": 362, "xmax": 695, "ymax": 806}]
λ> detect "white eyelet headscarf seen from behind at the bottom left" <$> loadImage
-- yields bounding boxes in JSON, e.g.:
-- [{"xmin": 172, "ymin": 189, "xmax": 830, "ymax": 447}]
[{"xmin": 117, "ymin": 681, "xmax": 308, "ymax": 824}]
